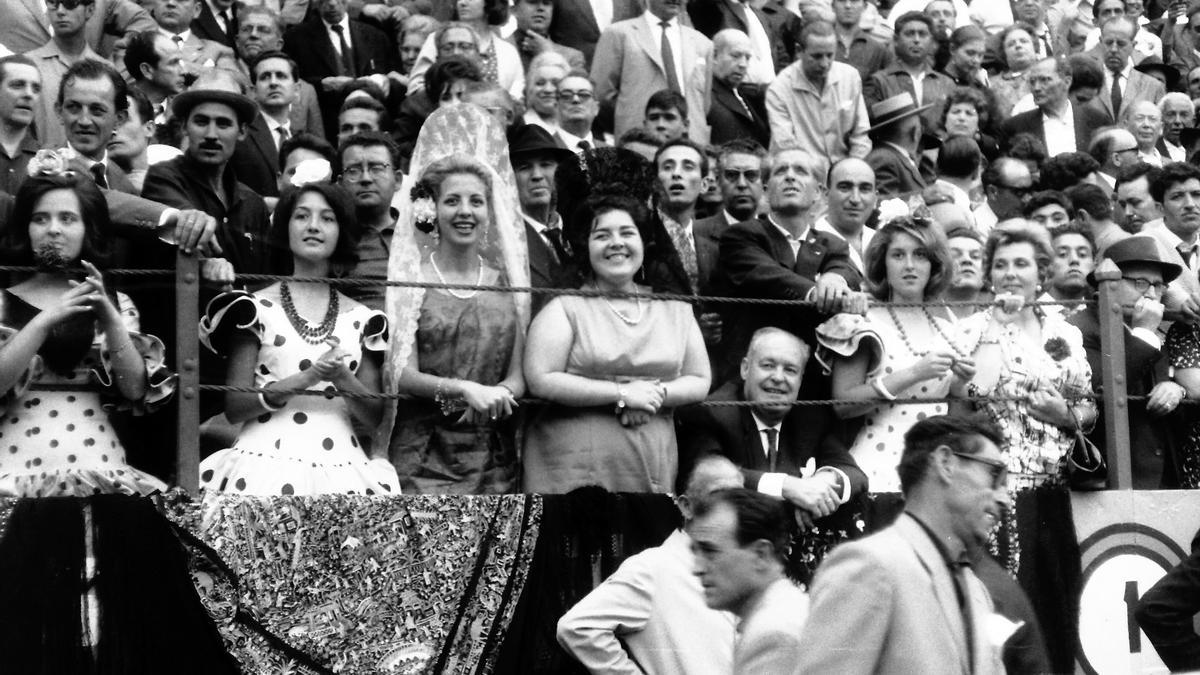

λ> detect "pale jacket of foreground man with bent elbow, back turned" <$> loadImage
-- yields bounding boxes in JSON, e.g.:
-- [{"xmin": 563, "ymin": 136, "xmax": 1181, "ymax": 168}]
[{"xmin": 558, "ymin": 530, "xmax": 734, "ymax": 675}]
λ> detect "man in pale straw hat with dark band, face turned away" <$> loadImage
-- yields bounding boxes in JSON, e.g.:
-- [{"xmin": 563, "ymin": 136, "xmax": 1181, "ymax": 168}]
[{"xmin": 865, "ymin": 91, "xmax": 932, "ymax": 199}]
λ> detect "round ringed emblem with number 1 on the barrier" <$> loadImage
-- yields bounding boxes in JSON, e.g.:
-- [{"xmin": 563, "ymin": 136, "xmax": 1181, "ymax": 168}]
[{"xmin": 1078, "ymin": 522, "xmax": 1187, "ymax": 675}]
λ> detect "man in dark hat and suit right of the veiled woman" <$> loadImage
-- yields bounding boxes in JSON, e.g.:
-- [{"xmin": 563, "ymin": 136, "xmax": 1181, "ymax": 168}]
[{"xmin": 509, "ymin": 124, "xmax": 577, "ymax": 313}]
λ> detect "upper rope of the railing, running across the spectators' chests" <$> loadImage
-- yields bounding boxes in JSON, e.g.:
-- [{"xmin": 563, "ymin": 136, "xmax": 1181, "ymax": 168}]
[{"xmin": 0, "ymin": 265, "xmax": 1096, "ymax": 307}]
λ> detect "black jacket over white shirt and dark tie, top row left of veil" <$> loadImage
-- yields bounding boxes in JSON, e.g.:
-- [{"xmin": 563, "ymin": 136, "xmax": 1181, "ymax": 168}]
[{"xmin": 283, "ymin": 17, "xmax": 398, "ymax": 138}]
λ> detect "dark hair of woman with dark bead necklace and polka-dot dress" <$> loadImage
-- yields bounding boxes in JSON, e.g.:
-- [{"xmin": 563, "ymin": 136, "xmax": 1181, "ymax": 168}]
[{"xmin": 266, "ymin": 183, "xmax": 362, "ymax": 277}]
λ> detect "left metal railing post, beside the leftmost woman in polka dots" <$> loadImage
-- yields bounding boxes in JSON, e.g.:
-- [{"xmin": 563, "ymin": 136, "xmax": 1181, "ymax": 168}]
[{"xmin": 175, "ymin": 252, "xmax": 200, "ymax": 495}]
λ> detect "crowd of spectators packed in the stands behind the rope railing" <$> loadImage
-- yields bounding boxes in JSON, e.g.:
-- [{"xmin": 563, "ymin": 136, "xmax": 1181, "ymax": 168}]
[{"xmin": 0, "ymin": 0, "xmax": 1200, "ymax": 663}]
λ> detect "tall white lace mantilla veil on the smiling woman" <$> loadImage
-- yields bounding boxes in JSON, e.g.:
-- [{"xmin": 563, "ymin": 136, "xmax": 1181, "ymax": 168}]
[{"xmin": 374, "ymin": 103, "xmax": 529, "ymax": 448}]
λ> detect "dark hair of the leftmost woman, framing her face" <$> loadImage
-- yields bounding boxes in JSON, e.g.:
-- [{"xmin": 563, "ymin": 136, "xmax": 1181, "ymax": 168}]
[{"xmin": 0, "ymin": 172, "xmax": 113, "ymax": 270}]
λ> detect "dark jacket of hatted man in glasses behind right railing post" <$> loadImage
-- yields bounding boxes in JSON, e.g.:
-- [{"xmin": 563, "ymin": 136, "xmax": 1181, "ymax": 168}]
[{"xmin": 1067, "ymin": 305, "xmax": 1182, "ymax": 490}]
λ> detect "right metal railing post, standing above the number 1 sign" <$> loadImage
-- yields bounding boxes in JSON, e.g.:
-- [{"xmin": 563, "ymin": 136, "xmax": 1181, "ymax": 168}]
[{"xmin": 1096, "ymin": 259, "xmax": 1133, "ymax": 490}]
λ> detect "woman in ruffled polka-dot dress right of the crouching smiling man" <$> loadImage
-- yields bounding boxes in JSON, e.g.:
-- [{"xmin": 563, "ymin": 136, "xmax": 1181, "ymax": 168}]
[{"xmin": 817, "ymin": 217, "xmax": 972, "ymax": 492}]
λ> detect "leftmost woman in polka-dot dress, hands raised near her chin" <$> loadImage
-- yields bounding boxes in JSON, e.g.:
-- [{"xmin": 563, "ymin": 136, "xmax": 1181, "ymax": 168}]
[{"xmin": 0, "ymin": 173, "xmax": 174, "ymax": 497}]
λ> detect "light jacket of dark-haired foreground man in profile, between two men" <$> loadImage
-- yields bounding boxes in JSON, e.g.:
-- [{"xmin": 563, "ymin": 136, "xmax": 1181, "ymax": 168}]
[{"xmin": 733, "ymin": 577, "xmax": 809, "ymax": 675}]
